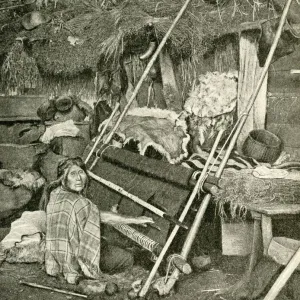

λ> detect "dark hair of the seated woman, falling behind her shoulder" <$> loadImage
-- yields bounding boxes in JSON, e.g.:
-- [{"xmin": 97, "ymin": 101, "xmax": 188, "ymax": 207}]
[{"xmin": 39, "ymin": 157, "xmax": 87, "ymax": 211}]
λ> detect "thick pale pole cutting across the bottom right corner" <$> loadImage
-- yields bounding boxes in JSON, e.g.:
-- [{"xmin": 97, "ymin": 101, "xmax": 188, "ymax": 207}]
[{"xmin": 264, "ymin": 248, "xmax": 300, "ymax": 300}]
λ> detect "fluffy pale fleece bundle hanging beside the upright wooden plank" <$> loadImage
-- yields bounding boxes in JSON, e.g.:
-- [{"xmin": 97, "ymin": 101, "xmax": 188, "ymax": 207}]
[{"xmin": 184, "ymin": 72, "xmax": 237, "ymax": 149}]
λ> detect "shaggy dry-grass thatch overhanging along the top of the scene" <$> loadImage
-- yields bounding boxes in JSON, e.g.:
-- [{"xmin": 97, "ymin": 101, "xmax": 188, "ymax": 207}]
[{"xmin": 0, "ymin": 0, "xmax": 275, "ymax": 77}]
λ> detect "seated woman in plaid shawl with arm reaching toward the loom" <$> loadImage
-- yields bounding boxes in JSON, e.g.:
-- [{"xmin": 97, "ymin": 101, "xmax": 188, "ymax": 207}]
[{"xmin": 41, "ymin": 158, "xmax": 153, "ymax": 284}]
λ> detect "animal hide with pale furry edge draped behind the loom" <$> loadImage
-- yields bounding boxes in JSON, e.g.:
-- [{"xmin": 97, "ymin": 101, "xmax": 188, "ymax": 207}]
[{"xmin": 102, "ymin": 107, "xmax": 190, "ymax": 164}]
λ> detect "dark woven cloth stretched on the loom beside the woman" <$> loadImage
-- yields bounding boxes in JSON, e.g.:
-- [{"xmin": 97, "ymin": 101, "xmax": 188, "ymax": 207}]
[{"xmin": 87, "ymin": 146, "xmax": 210, "ymax": 252}]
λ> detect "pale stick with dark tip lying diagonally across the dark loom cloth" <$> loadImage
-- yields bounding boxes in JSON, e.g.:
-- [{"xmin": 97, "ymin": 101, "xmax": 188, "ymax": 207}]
[{"xmin": 87, "ymin": 171, "xmax": 187, "ymax": 229}]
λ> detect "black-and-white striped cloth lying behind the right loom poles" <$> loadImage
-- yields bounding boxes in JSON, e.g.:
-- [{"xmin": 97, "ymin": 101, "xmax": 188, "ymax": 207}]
[{"xmin": 182, "ymin": 150, "xmax": 259, "ymax": 173}]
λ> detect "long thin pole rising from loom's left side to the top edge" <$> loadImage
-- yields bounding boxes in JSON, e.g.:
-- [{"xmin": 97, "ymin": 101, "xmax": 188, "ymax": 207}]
[{"xmin": 105, "ymin": 0, "xmax": 191, "ymax": 144}]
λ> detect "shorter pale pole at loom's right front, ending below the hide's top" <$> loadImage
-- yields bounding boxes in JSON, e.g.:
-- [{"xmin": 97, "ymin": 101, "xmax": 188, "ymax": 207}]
[{"xmin": 139, "ymin": 130, "xmax": 224, "ymax": 297}]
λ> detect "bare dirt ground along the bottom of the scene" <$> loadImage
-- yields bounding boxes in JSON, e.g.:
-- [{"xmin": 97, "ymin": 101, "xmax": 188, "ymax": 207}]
[{"xmin": 0, "ymin": 254, "xmax": 245, "ymax": 300}]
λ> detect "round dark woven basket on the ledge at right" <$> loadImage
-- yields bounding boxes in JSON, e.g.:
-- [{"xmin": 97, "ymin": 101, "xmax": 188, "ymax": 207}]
[{"xmin": 243, "ymin": 129, "xmax": 282, "ymax": 163}]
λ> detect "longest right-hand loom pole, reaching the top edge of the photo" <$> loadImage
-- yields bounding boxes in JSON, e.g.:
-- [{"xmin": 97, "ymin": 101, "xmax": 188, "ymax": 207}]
[{"xmin": 159, "ymin": 0, "xmax": 292, "ymax": 294}]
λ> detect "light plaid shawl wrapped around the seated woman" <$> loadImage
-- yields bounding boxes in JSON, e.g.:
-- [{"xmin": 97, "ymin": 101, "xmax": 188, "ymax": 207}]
[{"xmin": 45, "ymin": 187, "xmax": 100, "ymax": 284}]
